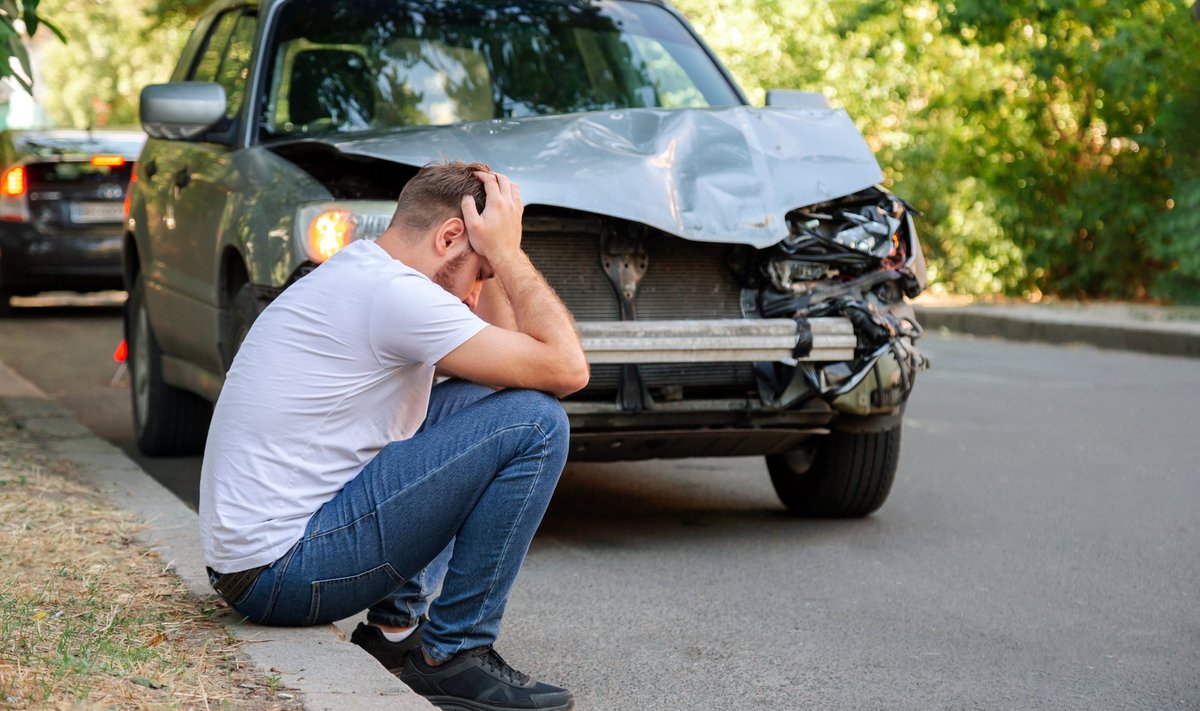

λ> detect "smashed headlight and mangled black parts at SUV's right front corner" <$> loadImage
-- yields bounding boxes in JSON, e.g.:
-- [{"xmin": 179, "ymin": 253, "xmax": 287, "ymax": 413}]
[{"xmin": 743, "ymin": 189, "xmax": 929, "ymax": 416}]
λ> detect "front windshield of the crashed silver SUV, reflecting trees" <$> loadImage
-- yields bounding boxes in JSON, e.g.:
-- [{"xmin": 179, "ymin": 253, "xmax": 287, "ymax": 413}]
[{"xmin": 260, "ymin": 0, "xmax": 740, "ymax": 141}]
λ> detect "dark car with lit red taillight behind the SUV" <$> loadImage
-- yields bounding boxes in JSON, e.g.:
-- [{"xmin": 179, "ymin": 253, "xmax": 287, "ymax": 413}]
[{"xmin": 0, "ymin": 130, "xmax": 145, "ymax": 312}]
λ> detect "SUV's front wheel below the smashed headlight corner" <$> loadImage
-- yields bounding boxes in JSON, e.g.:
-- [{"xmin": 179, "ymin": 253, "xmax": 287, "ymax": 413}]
[{"xmin": 767, "ymin": 422, "xmax": 900, "ymax": 519}]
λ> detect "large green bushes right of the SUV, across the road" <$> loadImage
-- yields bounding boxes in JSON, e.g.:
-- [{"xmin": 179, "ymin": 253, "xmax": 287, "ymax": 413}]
[{"xmin": 677, "ymin": 0, "xmax": 1200, "ymax": 300}]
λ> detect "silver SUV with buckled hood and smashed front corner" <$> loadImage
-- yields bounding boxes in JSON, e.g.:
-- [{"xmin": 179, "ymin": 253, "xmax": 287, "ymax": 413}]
[{"xmin": 125, "ymin": 0, "xmax": 925, "ymax": 516}]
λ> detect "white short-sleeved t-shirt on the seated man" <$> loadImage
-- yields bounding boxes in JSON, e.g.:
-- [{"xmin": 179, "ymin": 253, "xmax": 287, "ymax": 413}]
[{"xmin": 200, "ymin": 240, "xmax": 487, "ymax": 573}]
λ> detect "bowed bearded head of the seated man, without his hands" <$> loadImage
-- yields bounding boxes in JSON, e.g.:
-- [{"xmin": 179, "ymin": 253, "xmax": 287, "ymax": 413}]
[{"xmin": 379, "ymin": 161, "xmax": 492, "ymax": 307}]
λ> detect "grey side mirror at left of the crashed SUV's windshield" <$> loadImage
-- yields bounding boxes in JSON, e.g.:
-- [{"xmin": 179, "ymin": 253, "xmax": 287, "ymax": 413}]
[{"xmin": 139, "ymin": 82, "xmax": 226, "ymax": 141}]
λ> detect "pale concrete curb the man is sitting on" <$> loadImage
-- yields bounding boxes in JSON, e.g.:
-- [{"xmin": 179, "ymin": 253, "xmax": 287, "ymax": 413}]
[{"xmin": 0, "ymin": 363, "xmax": 433, "ymax": 711}]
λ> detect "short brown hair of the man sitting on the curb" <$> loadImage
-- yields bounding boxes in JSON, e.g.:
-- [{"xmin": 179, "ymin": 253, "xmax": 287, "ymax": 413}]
[{"xmin": 391, "ymin": 161, "xmax": 492, "ymax": 237}]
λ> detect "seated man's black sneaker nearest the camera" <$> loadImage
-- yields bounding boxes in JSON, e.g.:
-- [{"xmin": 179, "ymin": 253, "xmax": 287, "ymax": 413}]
[{"xmin": 400, "ymin": 646, "xmax": 575, "ymax": 711}]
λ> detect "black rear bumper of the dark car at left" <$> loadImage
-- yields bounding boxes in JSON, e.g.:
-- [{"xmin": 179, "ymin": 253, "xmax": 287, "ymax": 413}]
[{"xmin": 0, "ymin": 223, "xmax": 122, "ymax": 294}]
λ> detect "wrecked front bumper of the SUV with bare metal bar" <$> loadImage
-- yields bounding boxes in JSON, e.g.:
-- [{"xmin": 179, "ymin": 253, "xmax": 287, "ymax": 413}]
[{"xmin": 563, "ymin": 317, "xmax": 923, "ymax": 461}]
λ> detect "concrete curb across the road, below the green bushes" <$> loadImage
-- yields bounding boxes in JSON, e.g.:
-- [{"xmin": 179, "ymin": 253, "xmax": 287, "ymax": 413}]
[{"xmin": 914, "ymin": 305, "xmax": 1200, "ymax": 358}]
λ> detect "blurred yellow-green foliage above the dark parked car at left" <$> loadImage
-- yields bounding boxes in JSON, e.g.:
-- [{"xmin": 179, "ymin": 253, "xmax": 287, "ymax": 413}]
[{"xmin": 40, "ymin": 0, "xmax": 190, "ymax": 127}]
